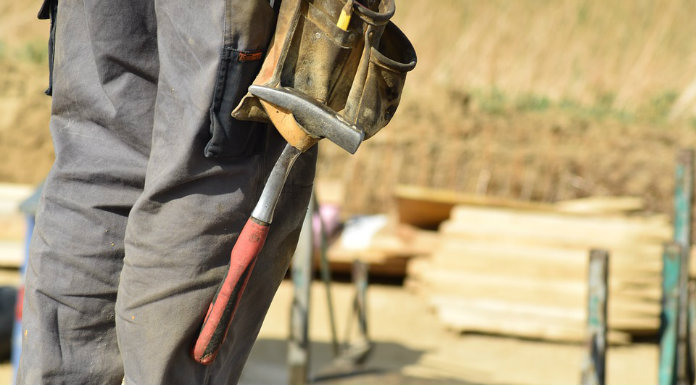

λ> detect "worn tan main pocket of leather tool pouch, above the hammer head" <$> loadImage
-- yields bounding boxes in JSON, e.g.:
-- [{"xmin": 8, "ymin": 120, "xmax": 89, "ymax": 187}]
[{"xmin": 233, "ymin": 0, "xmax": 363, "ymax": 121}]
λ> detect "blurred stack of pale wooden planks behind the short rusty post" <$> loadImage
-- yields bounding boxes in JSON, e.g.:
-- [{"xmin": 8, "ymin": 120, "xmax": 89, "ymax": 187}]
[{"xmin": 408, "ymin": 200, "xmax": 671, "ymax": 342}]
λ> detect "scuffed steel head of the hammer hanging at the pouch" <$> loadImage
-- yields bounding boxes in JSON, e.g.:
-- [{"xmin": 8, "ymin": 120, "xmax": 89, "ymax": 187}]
[{"xmin": 249, "ymin": 85, "xmax": 365, "ymax": 154}]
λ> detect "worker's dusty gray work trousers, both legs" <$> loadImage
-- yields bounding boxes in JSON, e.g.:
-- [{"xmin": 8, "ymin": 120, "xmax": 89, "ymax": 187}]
[{"xmin": 18, "ymin": 0, "xmax": 316, "ymax": 385}]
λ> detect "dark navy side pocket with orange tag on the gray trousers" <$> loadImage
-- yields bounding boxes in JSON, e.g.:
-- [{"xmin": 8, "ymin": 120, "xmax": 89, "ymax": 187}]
[{"xmin": 205, "ymin": 47, "xmax": 265, "ymax": 158}]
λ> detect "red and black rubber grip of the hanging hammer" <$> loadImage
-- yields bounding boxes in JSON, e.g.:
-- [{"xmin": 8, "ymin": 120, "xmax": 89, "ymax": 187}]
[{"xmin": 193, "ymin": 217, "xmax": 269, "ymax": 365}]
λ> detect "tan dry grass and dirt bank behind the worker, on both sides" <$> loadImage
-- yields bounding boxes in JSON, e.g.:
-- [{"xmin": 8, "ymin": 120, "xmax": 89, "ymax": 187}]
[{"xmin": 0, "ymin": 0, "xmax": 696, "ymax": 213}]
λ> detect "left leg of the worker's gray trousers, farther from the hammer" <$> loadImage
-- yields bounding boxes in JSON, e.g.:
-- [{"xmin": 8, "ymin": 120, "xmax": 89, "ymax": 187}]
[{"xmin": 18, "ymin": 0, "xmax": 158, "ymax": 385}]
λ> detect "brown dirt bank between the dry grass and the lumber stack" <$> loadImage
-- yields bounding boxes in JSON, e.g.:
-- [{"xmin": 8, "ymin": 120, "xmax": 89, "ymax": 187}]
[{"xmin": 319, "ymin": 105, "xmax": 696, "ymax": 213}]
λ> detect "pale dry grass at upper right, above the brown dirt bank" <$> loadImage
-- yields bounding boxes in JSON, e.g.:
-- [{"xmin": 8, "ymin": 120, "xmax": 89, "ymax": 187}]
[{"xmin": 395, "ymin": 0, "xmax": 696, "ymax": 124}]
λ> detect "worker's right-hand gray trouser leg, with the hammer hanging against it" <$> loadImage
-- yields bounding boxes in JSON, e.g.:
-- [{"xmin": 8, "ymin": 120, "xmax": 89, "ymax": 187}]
[{"xmin": 116, "ymin": 0, "xmax": 315, "ymax": 385}]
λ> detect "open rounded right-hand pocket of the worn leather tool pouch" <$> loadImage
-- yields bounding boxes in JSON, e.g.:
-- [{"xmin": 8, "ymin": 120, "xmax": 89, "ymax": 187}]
[{"xmin": 356, "ymin": 22, "xmax": 416, "ymax": 139}]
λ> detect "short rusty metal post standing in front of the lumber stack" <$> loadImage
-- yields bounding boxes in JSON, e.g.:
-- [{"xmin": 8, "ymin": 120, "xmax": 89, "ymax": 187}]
[{"xmin": 581, "ymin": 249, "xmax": 609, "ymax": 385}]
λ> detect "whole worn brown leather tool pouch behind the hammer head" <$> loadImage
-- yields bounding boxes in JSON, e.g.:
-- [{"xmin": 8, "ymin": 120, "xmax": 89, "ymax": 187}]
[{"xmin": 232, "ymin": 0, "xmax": 416, "ymax": 142}]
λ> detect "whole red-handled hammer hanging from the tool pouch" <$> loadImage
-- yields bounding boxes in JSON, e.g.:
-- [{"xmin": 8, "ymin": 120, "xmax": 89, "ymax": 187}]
[{"xmin": 192, "ymin": 85, "xmax": 364, "ymax": 365}]
